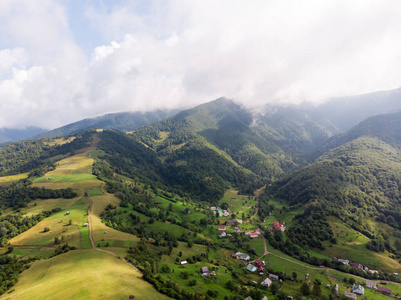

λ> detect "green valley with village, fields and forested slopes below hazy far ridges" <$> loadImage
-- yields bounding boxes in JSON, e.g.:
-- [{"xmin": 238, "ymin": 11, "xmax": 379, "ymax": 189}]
[{"xmin": 0, "ymin": 99, "xmax": 401, "ymax": 300}]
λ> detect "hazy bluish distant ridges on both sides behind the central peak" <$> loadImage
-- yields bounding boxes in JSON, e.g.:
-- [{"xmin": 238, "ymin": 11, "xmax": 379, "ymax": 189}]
[{"xmin": 0, "ymin": 89, "xmax": 401, "ymax": 144}]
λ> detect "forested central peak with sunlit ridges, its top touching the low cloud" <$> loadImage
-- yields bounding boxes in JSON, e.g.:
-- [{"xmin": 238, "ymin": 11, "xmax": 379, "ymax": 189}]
[{"xmin": 134, "ymin": 98, "xmax": 334, "ymax": 183}]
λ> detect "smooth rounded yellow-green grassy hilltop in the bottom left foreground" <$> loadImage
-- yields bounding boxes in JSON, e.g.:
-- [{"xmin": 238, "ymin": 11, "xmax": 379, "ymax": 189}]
[{"xmin": 0, "ymin": 249, "xmax": 170, "ymax": 300}]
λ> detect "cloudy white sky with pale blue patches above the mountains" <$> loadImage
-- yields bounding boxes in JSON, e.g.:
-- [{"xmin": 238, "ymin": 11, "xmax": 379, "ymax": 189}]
[{"xmin": 0, "ymin": 0, "xmax": 401, "ymax": 129}]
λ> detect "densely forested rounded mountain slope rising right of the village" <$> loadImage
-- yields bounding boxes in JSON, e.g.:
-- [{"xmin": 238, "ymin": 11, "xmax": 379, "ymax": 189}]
[{"xmin": 264, "ymin": 114, "xmax": 401, "ymax": 263}]
